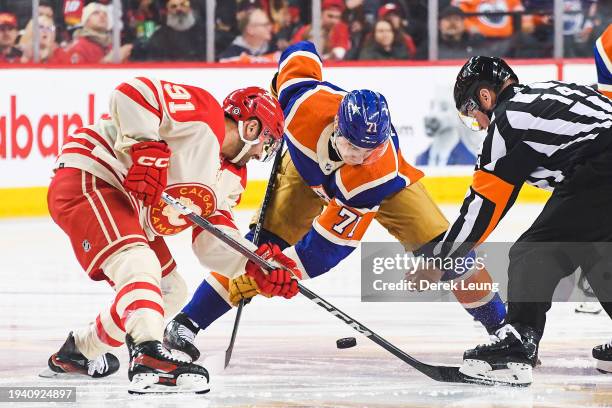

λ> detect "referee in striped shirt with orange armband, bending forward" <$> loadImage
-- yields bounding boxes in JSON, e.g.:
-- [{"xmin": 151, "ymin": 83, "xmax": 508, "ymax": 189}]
[{"xmin": 441, "ymin": 56, "xmax": 612, "ymax": 385}]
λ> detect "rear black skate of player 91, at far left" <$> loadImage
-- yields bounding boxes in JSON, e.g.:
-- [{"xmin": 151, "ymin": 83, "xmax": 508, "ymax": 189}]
[{"xmin": 40, "ymin": 332, "xmax": 119, "ymax": 378}]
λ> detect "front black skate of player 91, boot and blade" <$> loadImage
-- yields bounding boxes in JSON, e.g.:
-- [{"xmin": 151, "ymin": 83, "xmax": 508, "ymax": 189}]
[{"xmin": 125, "ymin": 335, "xmax": 210, "ymax": 394}]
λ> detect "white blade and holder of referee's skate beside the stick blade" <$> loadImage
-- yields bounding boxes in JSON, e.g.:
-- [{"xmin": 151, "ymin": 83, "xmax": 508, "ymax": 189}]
[{"xmin": 459, "ymin": 360, "xmax": 533, "ymax": 387}]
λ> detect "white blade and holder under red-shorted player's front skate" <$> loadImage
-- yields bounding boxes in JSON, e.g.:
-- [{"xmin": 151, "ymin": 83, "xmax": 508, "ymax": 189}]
[{"xmin": 128, "ymin": 374, "xmax": 210, "ymax": 395}]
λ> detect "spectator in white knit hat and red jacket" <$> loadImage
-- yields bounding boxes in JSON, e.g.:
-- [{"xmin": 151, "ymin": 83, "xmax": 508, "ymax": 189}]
[{"xmin": 67, "ymin": 3, "xmax": 132, "ymax": 64}]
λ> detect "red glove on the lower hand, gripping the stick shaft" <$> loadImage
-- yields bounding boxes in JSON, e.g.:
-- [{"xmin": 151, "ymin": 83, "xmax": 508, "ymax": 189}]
[{"xmin": 245, "ymin": 244, "xmax": 302, "ymax": 299}]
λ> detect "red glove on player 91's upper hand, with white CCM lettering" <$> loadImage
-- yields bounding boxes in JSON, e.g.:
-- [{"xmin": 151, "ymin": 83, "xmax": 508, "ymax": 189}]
[{"xmin": 123, "ymin": 142, "xmax": 170, "ymax": 205}]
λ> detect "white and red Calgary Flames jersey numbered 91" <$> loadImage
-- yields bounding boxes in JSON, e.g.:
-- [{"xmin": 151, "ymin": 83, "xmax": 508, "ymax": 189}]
[{"xmin": 56, "ymin": 77, "xmax": 254, "ymax": 278}]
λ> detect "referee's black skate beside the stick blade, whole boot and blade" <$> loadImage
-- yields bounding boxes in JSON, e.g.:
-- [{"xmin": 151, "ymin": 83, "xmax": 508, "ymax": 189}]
[{"xmin": 459, "ymin": 324, "xmax": 539, "ymax": 386}]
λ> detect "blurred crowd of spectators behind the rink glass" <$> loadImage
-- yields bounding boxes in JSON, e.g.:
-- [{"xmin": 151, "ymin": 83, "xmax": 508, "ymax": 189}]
[{"xmin": 0, "ymin": 0, "xmax": 612, "ymax": 64}]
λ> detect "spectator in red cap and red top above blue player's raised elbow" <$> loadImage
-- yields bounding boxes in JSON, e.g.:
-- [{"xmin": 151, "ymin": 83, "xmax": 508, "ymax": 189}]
[{"xmin": 292, "ymin": 0, "xmax": 351, "ymax": 60}]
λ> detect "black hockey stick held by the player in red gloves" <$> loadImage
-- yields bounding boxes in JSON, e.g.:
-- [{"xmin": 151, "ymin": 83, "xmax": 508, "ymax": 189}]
[{"xmin": 162, "ymin": 193, "xmax": 514, "ymax": 385}]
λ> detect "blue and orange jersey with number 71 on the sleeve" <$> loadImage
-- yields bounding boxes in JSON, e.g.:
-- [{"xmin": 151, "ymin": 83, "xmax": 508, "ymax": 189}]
[{"xmin": 277, "ymin": 41, "xmax": 423, "ymax": 277}]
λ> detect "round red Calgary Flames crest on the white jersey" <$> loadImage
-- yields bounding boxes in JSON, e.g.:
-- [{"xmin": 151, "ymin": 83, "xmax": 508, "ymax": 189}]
[{"xmin": 147, "ymin": 183, "xmax": 217, "ymax": 235}]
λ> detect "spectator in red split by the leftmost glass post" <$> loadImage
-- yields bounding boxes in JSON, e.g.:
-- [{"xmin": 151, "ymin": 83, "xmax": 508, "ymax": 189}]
[{"xmin": 19, "ymin": 15, "xmax": 69, "ymax": 64}]
